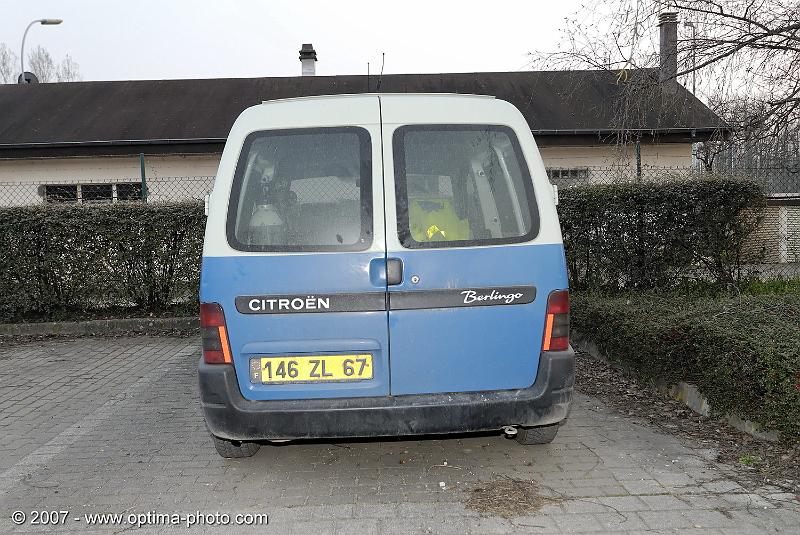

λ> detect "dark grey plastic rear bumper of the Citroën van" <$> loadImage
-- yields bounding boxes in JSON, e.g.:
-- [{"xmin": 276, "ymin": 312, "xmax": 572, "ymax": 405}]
[{"xmin": 199, "ymin": 348, "xmax": 575, "ymax": 440}]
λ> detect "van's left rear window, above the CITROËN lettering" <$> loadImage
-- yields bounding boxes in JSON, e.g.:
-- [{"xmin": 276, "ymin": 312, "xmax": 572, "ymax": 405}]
[{"xmin": 227, "ymin": 127, "xmax": 372, "ymax": 251}]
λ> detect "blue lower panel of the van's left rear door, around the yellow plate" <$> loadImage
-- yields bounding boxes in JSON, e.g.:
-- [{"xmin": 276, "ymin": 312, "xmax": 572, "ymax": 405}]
[{"xmin": 200, "ymin": 252, "xmax": 389, "ymax": 400}]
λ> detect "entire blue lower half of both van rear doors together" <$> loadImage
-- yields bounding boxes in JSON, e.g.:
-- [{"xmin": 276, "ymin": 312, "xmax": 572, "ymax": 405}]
[{"xmin": 200, "ymin": 244, "xmax": 567, "ymax": 400}]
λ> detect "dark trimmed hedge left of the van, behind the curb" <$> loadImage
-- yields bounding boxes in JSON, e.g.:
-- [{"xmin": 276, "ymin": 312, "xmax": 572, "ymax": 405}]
[{"xmin": 0, "ymin": 202, "xmax": 205, "ymax": 321}]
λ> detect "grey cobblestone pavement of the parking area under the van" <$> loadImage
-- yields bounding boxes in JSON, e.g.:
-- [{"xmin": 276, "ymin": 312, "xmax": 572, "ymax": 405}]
[{"xmin": 0, "ymin": 337, "xmax": 800, "ymax": 534}]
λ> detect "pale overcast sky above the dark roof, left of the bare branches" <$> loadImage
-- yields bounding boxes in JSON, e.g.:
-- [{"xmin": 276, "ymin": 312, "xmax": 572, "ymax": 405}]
[{"xmin": 0, "ymin": 0, "xmax": 579, "ymax": 80}]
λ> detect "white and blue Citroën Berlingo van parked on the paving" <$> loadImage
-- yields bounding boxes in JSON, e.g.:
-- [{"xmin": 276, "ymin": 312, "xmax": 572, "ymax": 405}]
[{"xmin": 199, "ymin": 94, "xmax": 575, "ymax": 457}]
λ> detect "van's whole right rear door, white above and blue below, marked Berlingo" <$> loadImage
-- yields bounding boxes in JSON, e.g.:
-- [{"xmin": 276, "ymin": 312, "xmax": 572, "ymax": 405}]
[{"xmin": 381, "ymin": 96, "xmax": 566, "ymax": 395}]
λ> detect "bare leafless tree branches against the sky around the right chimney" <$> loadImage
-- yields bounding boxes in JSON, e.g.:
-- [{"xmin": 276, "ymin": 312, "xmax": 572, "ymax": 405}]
[{"xmin": 532, "ymin": 0, "xmax": 800, "ymax": 140}]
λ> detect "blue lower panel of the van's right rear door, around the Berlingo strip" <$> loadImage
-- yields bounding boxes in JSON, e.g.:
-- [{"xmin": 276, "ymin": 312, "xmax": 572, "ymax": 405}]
[{"xmin": 388, "ymin": 244, "xmax": 567, "ymax": 395}]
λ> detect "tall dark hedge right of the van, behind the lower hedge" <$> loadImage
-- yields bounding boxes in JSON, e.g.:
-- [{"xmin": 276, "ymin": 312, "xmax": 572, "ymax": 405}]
[{"xmin": 558, "ymin": 179, "xmax": 764, "ymax": 291}]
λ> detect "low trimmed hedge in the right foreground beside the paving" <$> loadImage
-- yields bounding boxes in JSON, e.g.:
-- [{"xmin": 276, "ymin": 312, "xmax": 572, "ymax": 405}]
[{"xmin": 570, "ymin": 294, "xmax": 800, "ymax": 441}]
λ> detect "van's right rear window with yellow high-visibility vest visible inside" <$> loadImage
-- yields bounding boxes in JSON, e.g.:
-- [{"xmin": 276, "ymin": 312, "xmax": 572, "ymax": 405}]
[{"xmin": 393, "ymin": 125, "xmax": 539, "ymax": 249}]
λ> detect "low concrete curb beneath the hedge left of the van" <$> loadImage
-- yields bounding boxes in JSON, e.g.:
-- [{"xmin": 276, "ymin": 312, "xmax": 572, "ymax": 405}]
[{"xmin": 0, "ymin": 316, "xmax": 200, "ymax": 336}]
